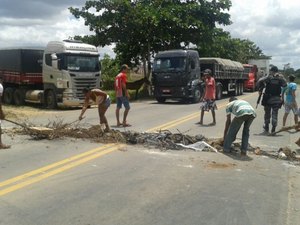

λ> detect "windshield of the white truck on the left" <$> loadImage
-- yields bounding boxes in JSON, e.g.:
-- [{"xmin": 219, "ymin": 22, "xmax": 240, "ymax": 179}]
[{"xmin": 61, "ymin": 55, "xmax": 100, "ymax": 72}]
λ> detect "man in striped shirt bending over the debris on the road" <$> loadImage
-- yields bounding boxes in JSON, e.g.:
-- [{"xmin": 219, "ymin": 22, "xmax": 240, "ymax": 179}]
[{"xmin": 223, "ymin": 97, "xmax": 256, "ymax": 156}]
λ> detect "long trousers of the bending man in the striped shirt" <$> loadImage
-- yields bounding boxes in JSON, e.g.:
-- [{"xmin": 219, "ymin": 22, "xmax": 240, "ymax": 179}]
[{"xmin": 223, "ymin": 115, "xmax": 255, "ymax": 152}]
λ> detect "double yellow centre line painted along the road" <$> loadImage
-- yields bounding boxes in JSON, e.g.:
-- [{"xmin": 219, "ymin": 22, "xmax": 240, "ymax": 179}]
[{"xmin": 0, "ymin": 92, "xmax": 255, "ymax": 196}]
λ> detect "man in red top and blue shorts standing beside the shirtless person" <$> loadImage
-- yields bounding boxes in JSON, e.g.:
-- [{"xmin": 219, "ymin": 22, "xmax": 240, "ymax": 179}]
[{"xmin": 115, "ymin": 64, "xmax": 131, "ymax": 127}]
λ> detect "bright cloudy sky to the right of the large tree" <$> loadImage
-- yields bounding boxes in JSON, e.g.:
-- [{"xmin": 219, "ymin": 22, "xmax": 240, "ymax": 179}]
[{"xmin": 224, "ymin": 0, "xmax": 300, "ymax": 69}]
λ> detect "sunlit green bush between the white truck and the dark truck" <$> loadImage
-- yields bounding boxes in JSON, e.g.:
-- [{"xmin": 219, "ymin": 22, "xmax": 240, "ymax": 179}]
[{"xmin": 101, "ymin": 54, "xmax": 120, "ymax": 90}]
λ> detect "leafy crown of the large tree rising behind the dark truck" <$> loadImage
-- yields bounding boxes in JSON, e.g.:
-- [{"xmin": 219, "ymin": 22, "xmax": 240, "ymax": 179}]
[{"xmin": 69, "ymin": 0, "xmax": 231, "ymax": 77}]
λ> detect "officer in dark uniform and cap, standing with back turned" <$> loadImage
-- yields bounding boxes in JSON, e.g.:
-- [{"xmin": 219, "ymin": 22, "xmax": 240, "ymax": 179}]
[{"xmin": 258, "ymin": 66, "xmax": 287, "ymax": 134}]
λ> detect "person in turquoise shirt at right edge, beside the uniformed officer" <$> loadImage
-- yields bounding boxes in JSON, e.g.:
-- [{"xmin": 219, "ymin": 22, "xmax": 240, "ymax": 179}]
[{"xmin": 281, "ymin": 75, "xmax": 298, "ymax": 127}]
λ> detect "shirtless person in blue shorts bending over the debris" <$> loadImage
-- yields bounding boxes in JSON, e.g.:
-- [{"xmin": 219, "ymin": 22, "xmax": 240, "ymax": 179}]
[{"xmin": 79, "ymin": 88, "xmax": 111, "ymax": 132}]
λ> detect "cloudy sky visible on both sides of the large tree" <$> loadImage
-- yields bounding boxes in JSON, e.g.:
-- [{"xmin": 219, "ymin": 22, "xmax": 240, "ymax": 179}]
[{"xmin": 0, "ymin": 0, "xmax": 300, "ymax": 69}]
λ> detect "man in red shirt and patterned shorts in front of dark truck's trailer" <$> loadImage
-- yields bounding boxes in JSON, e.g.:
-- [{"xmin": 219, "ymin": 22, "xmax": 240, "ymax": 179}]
[{"xmin": 197, "ymin": 69, "xmax": 217, "ymax": 126}]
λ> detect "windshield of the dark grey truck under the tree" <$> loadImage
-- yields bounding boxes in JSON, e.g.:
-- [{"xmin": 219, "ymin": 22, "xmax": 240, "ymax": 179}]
[{"xmin": 153, "ymin": 57, "xmax": 186, "ymax": 71}]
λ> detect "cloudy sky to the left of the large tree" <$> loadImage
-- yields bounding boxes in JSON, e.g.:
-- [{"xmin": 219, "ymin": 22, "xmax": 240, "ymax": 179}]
[{"xmin": 0, "ymin": 0, "xmax": 114, "ymax": 56}]
